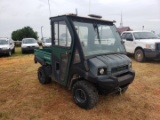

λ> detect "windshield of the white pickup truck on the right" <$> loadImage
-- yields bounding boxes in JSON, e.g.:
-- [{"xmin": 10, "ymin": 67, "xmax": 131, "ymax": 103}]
[{"xmin": 133, "ymin": 32, "xmax": 158, "ymax": 39}]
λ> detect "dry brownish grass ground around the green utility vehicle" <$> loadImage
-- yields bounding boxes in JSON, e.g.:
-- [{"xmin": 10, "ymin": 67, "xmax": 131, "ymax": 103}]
[{"xmin": 0, "ymin": 54, "xmax": 160, "ymax": 120}]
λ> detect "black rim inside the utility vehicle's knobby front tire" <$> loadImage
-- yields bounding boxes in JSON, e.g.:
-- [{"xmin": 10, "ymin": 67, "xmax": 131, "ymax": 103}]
[{"xmin": 75, "ymin": 89, "xmax": 87, "ymax": 103}]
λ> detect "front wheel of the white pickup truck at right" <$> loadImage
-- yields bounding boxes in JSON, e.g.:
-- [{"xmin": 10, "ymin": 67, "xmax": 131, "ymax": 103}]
[{"xmin": 134, "ymin": 49, "xmax": 145, "ymax": 62}]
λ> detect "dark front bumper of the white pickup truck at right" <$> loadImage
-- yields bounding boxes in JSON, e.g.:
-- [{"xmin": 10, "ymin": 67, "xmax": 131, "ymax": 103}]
[{"xmin": 144, "ymin": 49, "xmax": 160, "ymax": 59}]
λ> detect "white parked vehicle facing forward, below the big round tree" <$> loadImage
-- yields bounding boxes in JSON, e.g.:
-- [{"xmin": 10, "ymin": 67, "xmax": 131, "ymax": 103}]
[{"xmin": 21, "ymin": 38, "xmax": 39, "ymax": 53}]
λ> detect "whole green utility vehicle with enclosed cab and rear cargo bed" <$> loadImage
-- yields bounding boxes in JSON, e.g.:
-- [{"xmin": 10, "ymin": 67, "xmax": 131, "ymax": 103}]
[{"xmin": 34, "ymin": 14, "xmax": 135, "ymax": 109}]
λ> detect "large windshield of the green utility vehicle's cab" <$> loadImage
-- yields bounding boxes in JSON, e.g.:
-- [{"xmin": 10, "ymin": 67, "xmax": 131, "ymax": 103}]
[{"xmin": 74, "ymin": 22, "xmax": 125, "ymax": 56}]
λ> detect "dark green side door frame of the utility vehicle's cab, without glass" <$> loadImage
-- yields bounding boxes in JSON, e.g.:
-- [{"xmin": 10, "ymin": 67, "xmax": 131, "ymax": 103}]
[{"xmin": 51, "ymin": 16, "xmax": 74, "ymax": 85}]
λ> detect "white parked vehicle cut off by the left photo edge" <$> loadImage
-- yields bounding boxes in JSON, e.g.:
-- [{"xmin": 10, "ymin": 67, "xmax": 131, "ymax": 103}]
[{"xmin": 0, "ymin": 38, "xmax": 15, "ymax": 56}]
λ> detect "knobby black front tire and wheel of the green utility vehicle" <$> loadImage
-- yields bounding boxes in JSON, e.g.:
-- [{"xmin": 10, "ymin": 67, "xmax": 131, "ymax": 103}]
[{"xmin": 72, "ymin": 81, "xmax": 99, "ymax": 109}]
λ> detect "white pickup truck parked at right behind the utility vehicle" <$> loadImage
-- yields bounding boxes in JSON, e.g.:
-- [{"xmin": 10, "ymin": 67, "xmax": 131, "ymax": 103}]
[{"xmin": 122, "ymin": 31, "xmax": 160, "ymax": 62}]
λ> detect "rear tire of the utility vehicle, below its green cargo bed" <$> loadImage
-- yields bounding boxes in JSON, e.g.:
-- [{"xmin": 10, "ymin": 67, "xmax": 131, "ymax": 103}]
[{"xmin": 38, "ymin": 66, "xmax": 51, "ymax": 84}]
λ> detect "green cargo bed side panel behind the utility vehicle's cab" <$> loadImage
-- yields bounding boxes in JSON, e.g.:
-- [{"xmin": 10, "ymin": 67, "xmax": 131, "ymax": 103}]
[{"xmin": 34, "ymin": 48, "xmax": 52, "ymax": 65}]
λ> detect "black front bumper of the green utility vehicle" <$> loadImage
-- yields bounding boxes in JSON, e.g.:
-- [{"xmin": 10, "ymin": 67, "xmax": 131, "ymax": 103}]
[{"xmin": 98, "ymin": 70, "xmax": 135, "ymax": 93}]
